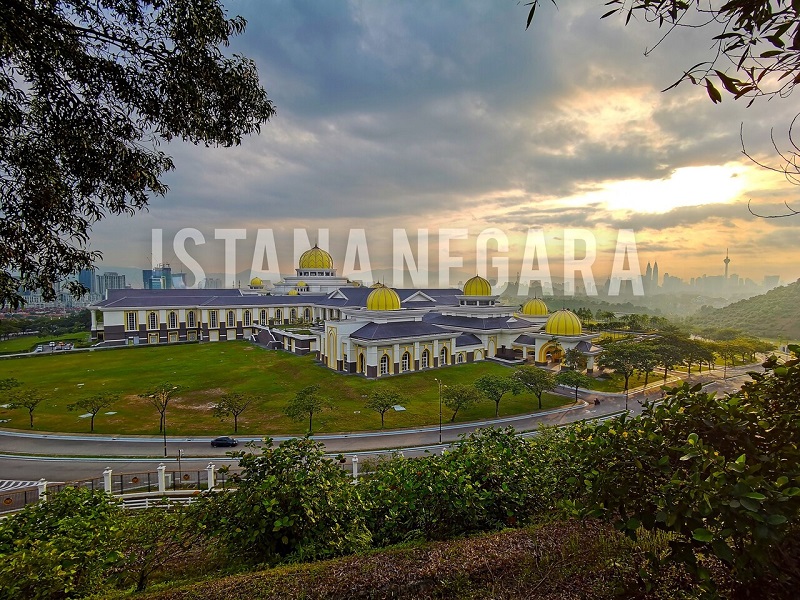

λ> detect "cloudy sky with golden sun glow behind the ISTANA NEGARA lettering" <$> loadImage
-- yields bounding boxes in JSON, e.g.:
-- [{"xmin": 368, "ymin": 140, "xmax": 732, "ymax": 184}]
[{"xmin": 92, "ymin": 0, "xmax": 800, "ymax": 286}]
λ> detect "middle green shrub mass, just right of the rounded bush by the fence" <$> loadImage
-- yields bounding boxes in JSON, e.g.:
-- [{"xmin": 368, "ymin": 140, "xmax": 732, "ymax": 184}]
[{"xmin": 361, "ymin": 429, "xmax": 551, "ymax": 546}]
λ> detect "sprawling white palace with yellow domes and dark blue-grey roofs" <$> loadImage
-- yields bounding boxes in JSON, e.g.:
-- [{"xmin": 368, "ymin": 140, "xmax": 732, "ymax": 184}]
[{"xmin": 90, "ymin": 246, "xmax": 600, "ymax": 378}]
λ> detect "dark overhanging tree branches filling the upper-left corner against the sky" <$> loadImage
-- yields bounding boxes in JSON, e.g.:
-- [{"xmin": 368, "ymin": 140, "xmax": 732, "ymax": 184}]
[{"xmin": 0, "ymin": 0, "xmax": 275, "ymax": 306}]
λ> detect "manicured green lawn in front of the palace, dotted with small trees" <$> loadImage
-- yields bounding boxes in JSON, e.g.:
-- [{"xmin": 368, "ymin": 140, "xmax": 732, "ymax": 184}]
[{"xmin": 0, "ymin": 342, "xmax": 571, "ymax": 435}]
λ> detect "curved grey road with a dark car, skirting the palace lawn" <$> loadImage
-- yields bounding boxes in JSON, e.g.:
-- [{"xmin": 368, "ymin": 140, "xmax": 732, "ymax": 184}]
[{"xmin": 0, "ymin": 365, "xmax": 756, "ymax": 481}]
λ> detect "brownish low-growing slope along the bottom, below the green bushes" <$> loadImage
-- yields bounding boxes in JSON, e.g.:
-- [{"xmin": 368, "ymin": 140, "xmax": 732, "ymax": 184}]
[{"xmin": 145, "ymin": 521, "xmax": 704, "ymax": 600}]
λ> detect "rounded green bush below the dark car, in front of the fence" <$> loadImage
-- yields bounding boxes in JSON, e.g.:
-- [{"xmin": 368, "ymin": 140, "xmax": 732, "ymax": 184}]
[{"xmin": 202, "ymin": 438, "xmax": 371, "ymax": 562}]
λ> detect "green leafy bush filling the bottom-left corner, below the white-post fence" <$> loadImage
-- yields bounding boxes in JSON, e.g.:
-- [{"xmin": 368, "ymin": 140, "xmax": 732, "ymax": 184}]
[{"xmin": 0, "ymin": 488, "xmax": 122, "ymax": 600}]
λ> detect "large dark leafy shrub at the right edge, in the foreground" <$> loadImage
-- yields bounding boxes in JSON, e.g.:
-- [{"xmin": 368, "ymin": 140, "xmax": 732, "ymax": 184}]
[{"xmin": 565, "ymin": 347, "xmax": 800, "ymax": 581}]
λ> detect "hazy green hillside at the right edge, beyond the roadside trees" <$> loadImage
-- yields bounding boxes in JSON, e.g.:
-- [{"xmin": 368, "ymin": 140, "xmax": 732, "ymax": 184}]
[{"xmin": 690, "ymin": 279, "xmax": 800, "ymax": 340}]
